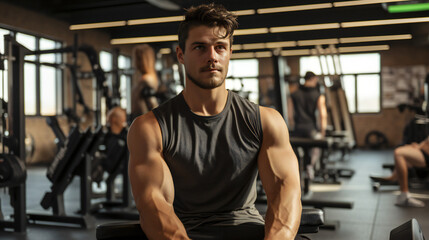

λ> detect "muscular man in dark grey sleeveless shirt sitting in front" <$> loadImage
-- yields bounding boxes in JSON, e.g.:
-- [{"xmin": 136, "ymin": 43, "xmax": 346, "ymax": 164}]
[{"xmin": 128, "ymin": 4, "xmax": 302, "ymax": 240}]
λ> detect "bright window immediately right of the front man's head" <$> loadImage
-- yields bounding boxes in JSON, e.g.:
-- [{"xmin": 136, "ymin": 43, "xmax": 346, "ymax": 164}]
[{"xmin": 225, "ymin": 59, "xmax": 259, "ymax": 103}]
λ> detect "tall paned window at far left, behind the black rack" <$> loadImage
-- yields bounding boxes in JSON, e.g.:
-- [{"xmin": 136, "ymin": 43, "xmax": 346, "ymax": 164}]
[{"xmin": 0, "ymin": 29, "xmax": 63, "ymax": 116}]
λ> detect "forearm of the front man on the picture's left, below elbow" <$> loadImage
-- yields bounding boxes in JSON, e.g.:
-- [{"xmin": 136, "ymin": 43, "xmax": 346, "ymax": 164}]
[{"xmin": 139, "ymin": 193, "xmax": 189, "ymax": 240}]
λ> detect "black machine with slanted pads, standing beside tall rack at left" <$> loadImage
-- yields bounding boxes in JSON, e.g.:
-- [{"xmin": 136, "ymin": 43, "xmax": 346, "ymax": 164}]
[{"xmin": 27, "ymin": 127, "xmax": 103, "ymax": 228}]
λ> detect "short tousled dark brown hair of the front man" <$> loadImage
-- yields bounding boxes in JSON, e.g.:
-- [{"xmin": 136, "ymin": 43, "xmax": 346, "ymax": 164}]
[{"xmin": 178, "ymin": 3, "xmax": 238, "ymax": 52}]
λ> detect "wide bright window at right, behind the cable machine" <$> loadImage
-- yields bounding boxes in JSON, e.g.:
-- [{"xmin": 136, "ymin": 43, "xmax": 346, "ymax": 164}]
[{"xmin": 300, "ymin": 53, "xmax": 381, "ymax": 113}]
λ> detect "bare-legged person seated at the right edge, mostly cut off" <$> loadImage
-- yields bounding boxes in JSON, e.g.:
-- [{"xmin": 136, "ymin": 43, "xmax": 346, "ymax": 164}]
[{"xmin": 370, "ymin": 137, "xmax": 429, "ymax": 207}]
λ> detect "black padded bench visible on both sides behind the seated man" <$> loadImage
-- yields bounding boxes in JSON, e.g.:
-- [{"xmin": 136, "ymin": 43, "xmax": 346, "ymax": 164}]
[{"xmin": 96, "ymin": 208, "xmax": 324, "ymax": 240}]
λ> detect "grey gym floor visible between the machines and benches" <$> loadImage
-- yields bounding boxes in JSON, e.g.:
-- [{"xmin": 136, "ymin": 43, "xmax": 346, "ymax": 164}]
[{"xmin": 0, "ymin": 150, "xmax": 429, "ymax": 240}]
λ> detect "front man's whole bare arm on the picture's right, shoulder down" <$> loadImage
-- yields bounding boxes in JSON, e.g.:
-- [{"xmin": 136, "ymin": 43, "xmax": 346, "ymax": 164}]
[{"xmin": 258, "ymin": 107, "xmax": 302, "ymax": 240}]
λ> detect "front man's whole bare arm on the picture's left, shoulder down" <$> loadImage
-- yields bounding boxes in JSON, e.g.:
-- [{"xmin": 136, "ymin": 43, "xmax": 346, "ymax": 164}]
[{"xmin": 127, "ymin": 112, "xmax": 189, "ymax": 240}]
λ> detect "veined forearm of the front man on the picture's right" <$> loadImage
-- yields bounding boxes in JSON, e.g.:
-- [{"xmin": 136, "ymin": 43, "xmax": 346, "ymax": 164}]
[{"xmin": 265, "ymin": 186, "xmax": 302, "ymax": 240}]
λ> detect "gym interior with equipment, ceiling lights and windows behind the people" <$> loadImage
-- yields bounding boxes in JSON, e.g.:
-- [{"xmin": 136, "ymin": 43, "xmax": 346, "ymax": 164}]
[{"xmin": 0, "ymin": 0, "xmax": 429, "ymax": 240}]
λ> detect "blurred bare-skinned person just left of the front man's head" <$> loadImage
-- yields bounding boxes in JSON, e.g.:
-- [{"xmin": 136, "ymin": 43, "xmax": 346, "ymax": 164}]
[{"xmin": 130, "ymin": 44, "xmax": 159, "ymax": 122}]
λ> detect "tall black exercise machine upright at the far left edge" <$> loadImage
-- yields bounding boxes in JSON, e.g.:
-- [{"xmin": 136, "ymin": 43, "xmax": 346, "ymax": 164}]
[{"xmin": 0, "ymin": 35, "xmax": 30, "ymax": 232}]
